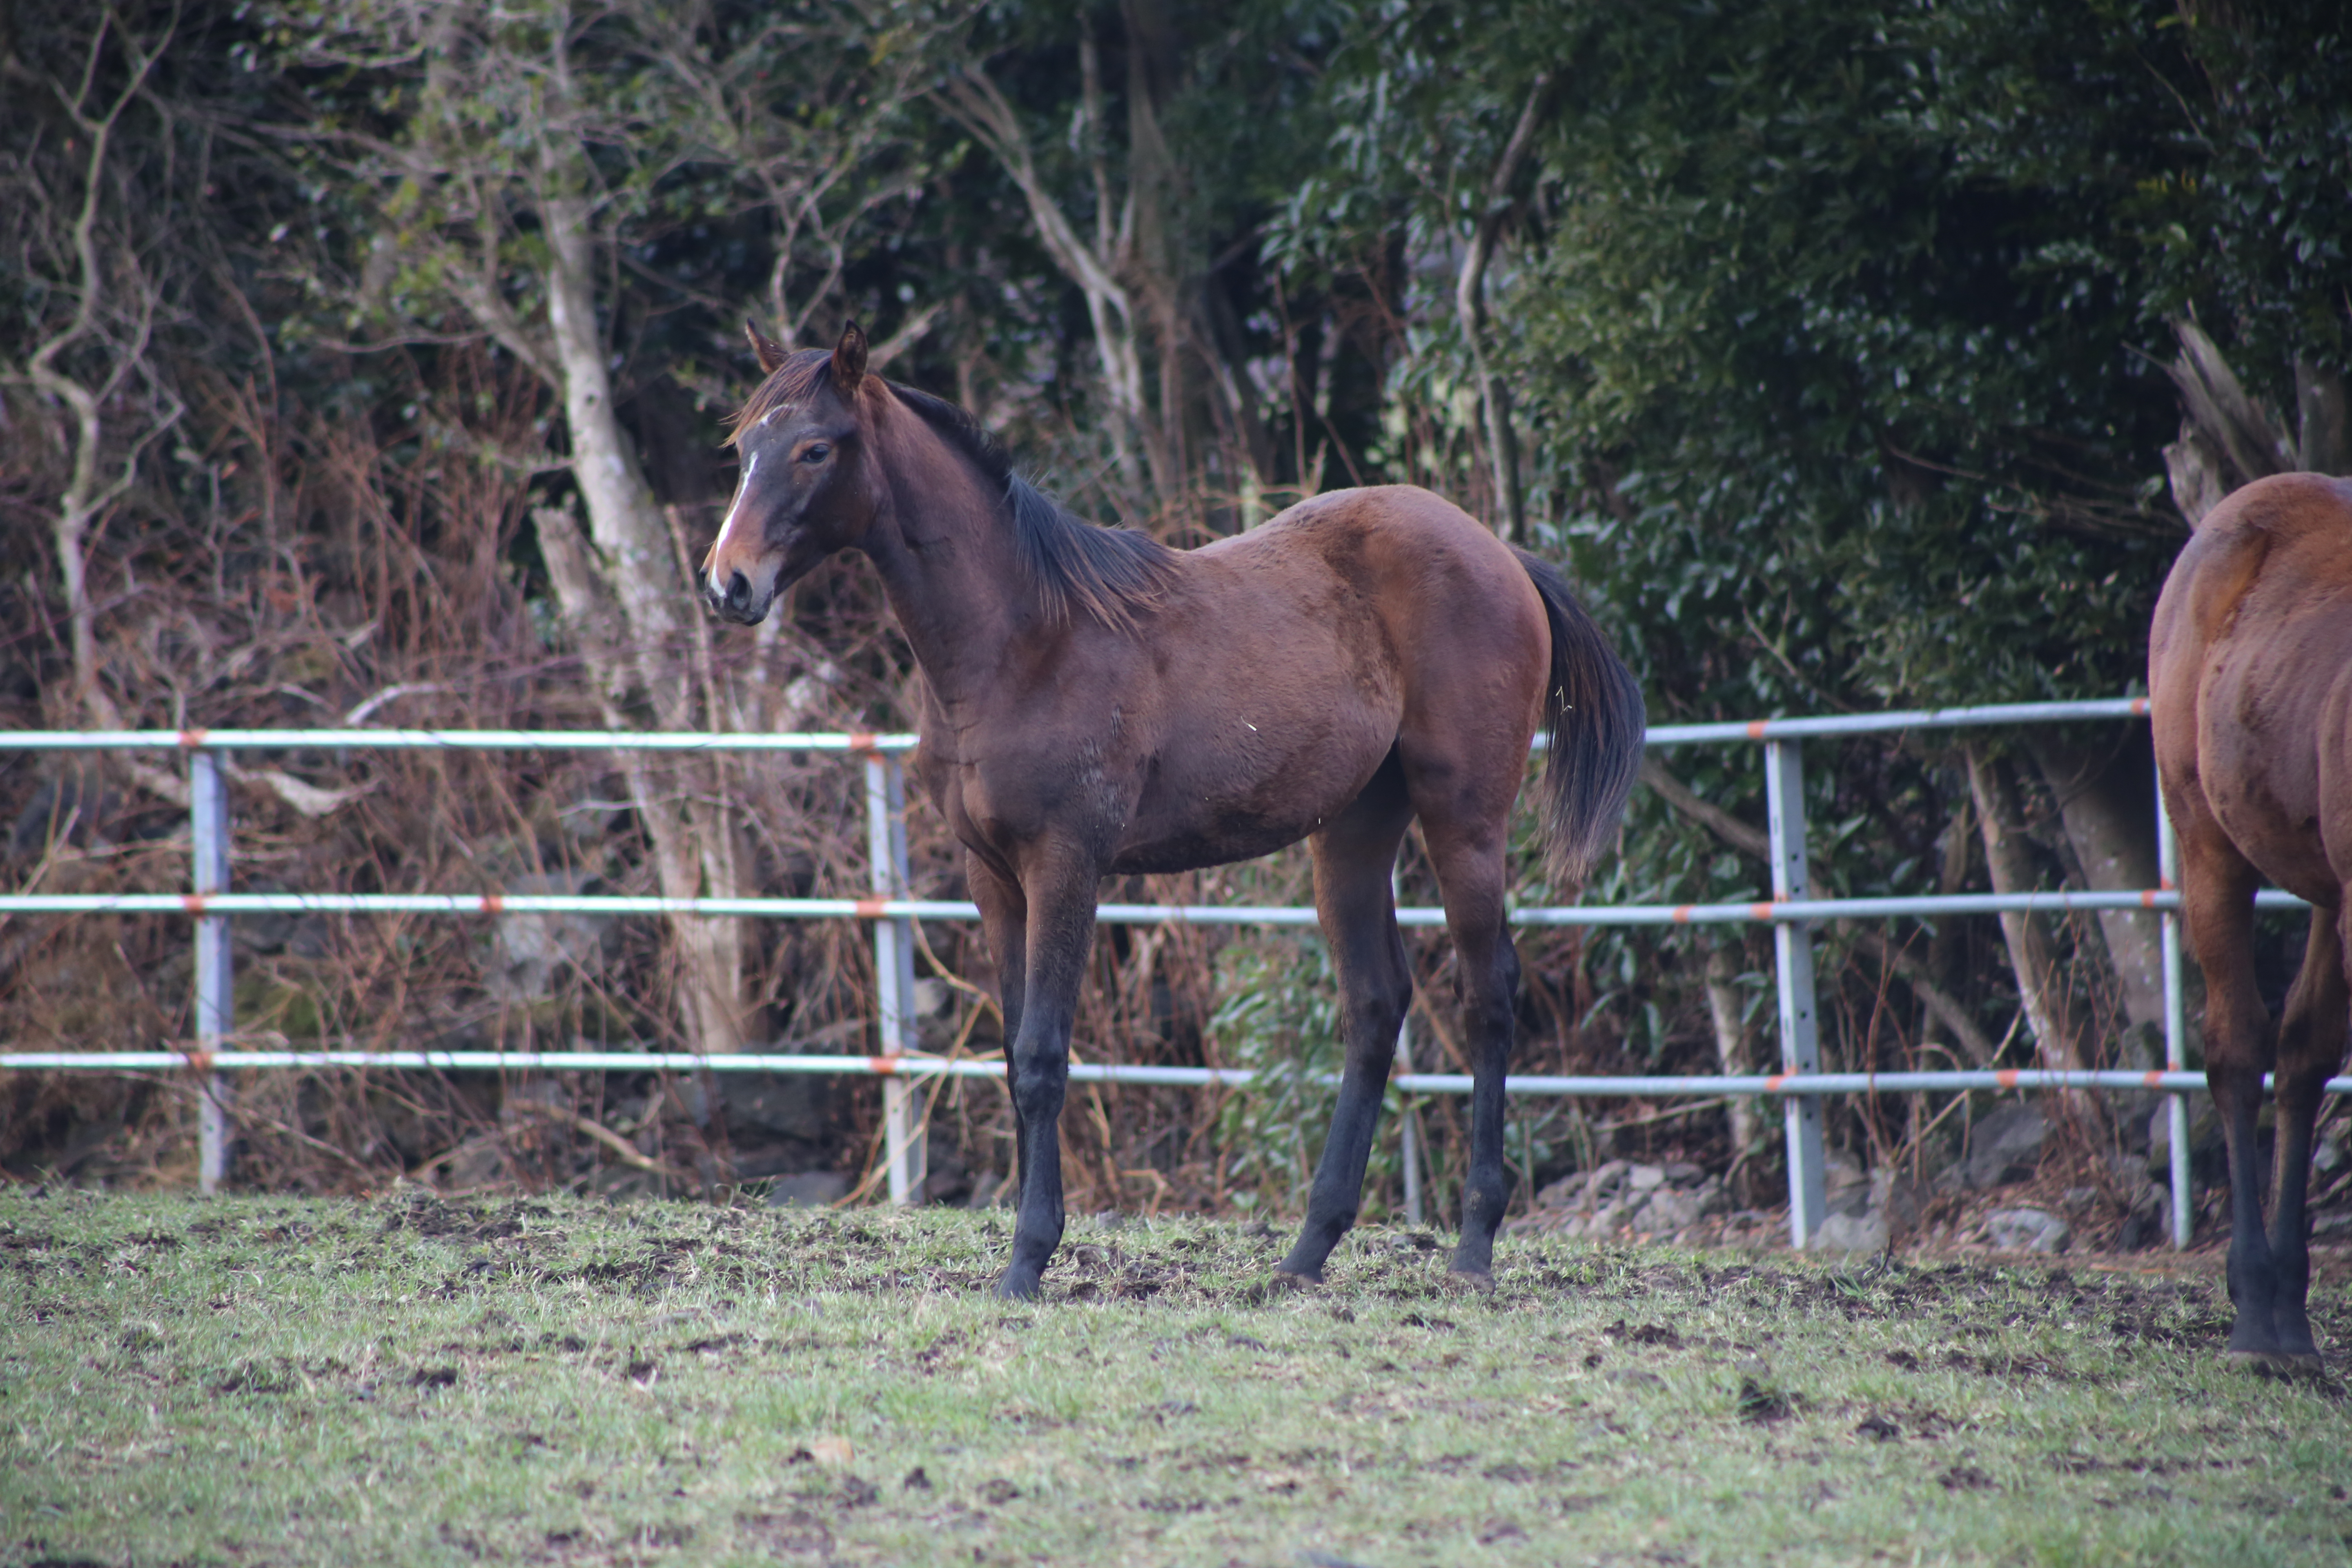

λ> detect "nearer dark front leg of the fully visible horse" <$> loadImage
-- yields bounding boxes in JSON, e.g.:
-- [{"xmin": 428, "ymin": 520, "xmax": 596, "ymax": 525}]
[{"xmin": 997, "ymin": 858, "xmax": 1096, "ymax": 1300}]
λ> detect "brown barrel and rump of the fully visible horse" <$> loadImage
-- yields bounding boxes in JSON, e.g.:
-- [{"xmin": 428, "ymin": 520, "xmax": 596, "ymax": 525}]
[{"xmin": 1077, "ymin": 487, "xmax": 1550, "ymax": 870}]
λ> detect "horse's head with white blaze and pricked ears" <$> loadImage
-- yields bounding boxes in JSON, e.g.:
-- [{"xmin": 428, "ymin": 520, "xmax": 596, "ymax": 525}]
[{"xmin": 703, "ymin": 322, "xmax": 873, "ymax": 625}]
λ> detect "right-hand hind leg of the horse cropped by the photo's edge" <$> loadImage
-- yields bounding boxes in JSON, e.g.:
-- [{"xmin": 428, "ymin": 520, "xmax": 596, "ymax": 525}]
[{"xmin": 2270, "ymin": 889, "xmax": 2352, "ymax": 1373}]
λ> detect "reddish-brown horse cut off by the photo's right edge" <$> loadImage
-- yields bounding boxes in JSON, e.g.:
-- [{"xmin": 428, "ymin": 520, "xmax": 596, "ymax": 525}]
[{"xmin": 2147, "ymin": 472, "xmax": 2352, "ymax": 1368}]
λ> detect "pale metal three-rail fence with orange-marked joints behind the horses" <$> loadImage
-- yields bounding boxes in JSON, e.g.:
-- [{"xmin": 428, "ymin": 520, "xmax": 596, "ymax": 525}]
[{"xmin": 0, "ymin": 698, "xmax": 2323, "ymax": 1248}]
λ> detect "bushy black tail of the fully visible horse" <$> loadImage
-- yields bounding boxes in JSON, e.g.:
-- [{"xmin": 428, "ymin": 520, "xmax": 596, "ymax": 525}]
[{"xmin": 1515, "ymin": 550, "xmax": 1649, "ymax": 895}]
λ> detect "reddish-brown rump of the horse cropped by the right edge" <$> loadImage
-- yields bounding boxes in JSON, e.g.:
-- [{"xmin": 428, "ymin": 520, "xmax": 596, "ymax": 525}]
[{"xmin": 2147, "ymin": 472, "xmax": 2352, "ymax": 903}]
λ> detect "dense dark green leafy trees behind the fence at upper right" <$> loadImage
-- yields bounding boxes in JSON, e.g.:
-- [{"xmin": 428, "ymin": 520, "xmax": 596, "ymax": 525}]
[{"xmin": 1275, "ymin": 0, "xmax": 2352, "ymax": 715}]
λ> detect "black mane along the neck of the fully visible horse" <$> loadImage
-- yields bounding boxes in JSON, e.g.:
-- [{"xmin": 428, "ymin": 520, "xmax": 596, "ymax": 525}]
[{"xmin": 889, "ymin": 381, "xmax": 1176, "ymax": 630}]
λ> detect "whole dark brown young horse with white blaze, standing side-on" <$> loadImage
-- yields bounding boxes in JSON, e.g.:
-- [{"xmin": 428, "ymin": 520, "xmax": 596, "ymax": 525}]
[{"xmin": 703, "ymin": 324, "xmax": 1642, "ymax": 1298}]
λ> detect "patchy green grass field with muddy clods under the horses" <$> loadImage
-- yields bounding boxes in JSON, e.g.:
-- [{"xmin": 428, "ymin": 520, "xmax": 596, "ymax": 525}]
[{"xmin": 0, "ymin": 1187, "xmax": 2352, "ymax": 1568}]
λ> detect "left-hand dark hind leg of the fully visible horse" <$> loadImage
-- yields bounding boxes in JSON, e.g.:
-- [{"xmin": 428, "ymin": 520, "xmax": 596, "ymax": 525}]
[{"xmin": 1275, "ymin": 757, "xmax": 1414, "ymax": 1281}]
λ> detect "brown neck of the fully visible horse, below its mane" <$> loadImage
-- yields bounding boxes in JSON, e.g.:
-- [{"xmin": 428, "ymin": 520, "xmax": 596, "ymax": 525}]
[{"xmin": 866, "ymin": 404, "xmax": 1035, "ymax": 708}]
